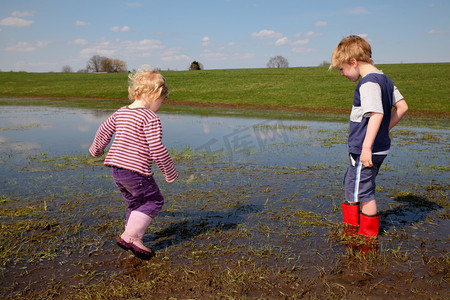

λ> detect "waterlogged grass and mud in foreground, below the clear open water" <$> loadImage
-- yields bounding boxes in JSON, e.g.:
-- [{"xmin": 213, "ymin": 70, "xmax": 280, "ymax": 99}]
[{"xmin": 0, "ymin": 102, "xmax": 450, "ymax": 299}]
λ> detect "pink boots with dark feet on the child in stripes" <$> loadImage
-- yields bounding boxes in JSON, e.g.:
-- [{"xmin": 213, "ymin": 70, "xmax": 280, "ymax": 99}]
[{"xmin": 117, "ymin": 211, "xmax": 154, "ymax": 259}]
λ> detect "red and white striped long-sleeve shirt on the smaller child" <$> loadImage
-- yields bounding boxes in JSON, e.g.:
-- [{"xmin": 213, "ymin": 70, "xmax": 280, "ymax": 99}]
[{"xmin": 89, "ymin": 106, "xmax": 178, "ymax": 183}]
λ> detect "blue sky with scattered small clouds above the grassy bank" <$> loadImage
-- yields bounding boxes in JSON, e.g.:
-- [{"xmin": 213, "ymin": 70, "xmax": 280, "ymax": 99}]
[{"xmin": 0, "ymin": 0, "xmax": 450, "ymax": 72}]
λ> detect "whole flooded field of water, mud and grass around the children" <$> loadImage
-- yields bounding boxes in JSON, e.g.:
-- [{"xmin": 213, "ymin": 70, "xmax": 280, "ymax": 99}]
[{"xmin": 0, "ymin": 102, "xmax": 450, "ymax": 299}]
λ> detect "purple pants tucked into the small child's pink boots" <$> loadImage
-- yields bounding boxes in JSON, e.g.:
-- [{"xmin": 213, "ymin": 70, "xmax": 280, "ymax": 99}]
[{"xmin": 112, "ymin": 167, "xmax": 164, "ymax": 222}]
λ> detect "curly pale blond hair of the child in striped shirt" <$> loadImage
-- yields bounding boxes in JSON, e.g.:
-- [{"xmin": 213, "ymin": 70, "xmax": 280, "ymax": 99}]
[{"xmin": 128, "ymin": 66, "xmax": 169, "ymax": 101}]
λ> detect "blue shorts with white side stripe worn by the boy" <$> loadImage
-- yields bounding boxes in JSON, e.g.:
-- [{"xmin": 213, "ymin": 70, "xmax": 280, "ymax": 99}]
[{"xmin": 344, "ymin": 154, "xmax": 386, "ymax": 202}]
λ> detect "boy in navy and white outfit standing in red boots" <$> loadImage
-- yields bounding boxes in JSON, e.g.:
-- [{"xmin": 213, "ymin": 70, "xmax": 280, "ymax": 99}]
[{"xmin": 330, "ymin": 35, "xmax": 408, "ymax": 237}]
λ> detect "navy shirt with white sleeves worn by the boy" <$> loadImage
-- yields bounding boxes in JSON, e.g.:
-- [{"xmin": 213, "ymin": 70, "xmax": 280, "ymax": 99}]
[{"xmin": 348, "ymin": 70, "xmax": 403, "ymax": 155}]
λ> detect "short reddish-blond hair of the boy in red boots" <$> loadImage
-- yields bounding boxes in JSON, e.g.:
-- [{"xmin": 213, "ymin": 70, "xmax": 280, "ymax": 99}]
[{"xmin": 330, "ymin": 35, "xmax": 373, "ymax": 69}]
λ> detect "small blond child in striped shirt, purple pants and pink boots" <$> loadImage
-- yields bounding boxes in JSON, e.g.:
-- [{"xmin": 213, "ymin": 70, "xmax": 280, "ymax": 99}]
[{"xmin": 89, "ymin": 67, "xmax": 178, "ymax": 259}]
